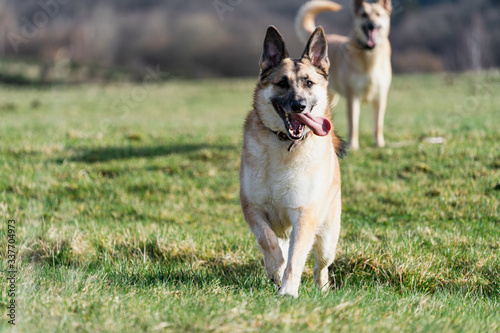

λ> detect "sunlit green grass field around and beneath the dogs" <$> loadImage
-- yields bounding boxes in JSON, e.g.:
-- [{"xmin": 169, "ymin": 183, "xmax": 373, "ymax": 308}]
[{"xmin": 0, "ymin": 72, "xmax": 500, "ymax": 332}]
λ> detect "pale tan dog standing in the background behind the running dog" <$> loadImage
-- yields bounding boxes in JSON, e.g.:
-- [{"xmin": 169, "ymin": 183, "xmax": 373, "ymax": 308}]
[{"xmin": 295, "ymin": 0, "xmax": 392, "ymax": 149}]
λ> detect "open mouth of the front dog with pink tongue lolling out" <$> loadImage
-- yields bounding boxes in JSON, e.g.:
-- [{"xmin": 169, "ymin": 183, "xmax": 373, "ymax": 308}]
[{"xmin": 274, "ymin": 104, "xmax": 332, "ymax": 140}]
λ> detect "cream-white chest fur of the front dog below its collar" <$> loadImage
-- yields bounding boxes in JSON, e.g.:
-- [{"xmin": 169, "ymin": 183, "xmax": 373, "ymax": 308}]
[{"xmin": 241, "ymin": 136, "xmax": 335, "ymax": 216}]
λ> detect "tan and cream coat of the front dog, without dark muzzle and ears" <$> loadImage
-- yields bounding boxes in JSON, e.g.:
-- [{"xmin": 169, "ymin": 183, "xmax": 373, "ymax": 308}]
[{"xmin": 240, "ymin": 29, "xmax": 342, "ymax": 297}]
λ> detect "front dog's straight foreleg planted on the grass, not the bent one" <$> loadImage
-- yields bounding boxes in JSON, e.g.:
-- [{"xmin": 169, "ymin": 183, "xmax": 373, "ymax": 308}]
[{"xmin": 278, "ymin": 209, "xmax": 317, "ymax": 297}]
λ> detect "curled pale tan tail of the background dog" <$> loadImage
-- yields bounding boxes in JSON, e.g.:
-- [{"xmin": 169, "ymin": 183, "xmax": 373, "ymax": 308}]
[{"xmin": 295, "ymin": 0, "xmax": 342, "ymax": 42}]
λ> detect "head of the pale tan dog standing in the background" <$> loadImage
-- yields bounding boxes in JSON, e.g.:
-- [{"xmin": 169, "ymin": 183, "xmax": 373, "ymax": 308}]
[{"xmin": 353, "ymin": 0, "xmax": 392, "ymax": 49}]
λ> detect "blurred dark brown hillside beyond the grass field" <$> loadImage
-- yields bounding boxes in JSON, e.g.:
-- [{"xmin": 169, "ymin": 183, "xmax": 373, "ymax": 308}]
[{"xmin": 0, "ymin": 0, "xmax": 500, "ymax": 80}]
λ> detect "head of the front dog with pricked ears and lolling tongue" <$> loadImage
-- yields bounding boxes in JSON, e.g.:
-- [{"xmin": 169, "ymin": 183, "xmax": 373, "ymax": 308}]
[{"xmin": 254, "ymin": 26, "xmax": 332, "ymax": 140}]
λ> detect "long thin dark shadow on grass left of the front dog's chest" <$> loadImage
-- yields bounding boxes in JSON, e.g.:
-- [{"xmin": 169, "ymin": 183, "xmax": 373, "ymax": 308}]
[{"xmin": 66, "ymin": 143, "xmax": 236, "ymax": 163}]
